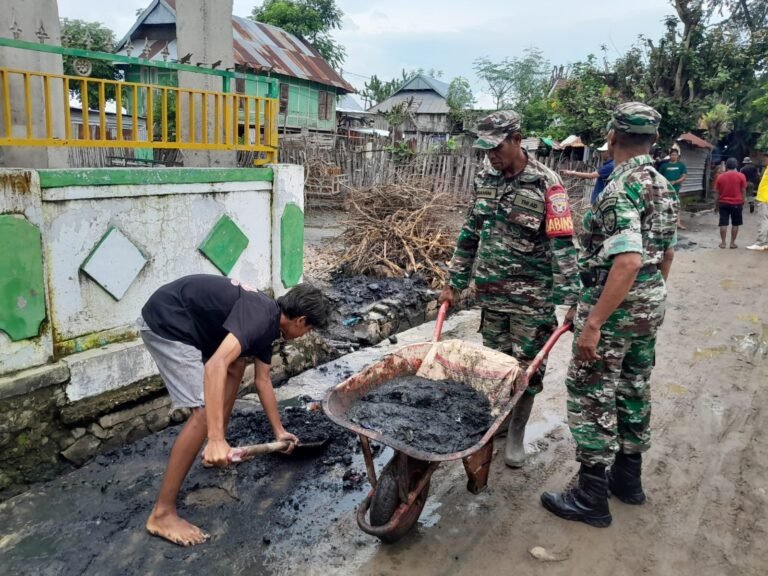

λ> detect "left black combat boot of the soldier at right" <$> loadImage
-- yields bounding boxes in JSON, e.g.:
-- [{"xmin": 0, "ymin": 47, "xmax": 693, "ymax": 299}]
[{"xmin": 541, "ymin": 464, "xmax": 612, "ymax": 528}]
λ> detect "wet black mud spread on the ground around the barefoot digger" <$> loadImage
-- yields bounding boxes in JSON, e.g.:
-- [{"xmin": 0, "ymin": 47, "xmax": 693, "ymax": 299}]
[{"xmin": 0, "ymin": 405, "xmax": 368, "ymax": 576}]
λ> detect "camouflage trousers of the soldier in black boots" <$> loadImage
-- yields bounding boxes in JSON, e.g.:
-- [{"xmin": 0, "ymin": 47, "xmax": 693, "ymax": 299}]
[{"xmin": 566, "ymin": 292, "xmax": 664, "ymax": 466}]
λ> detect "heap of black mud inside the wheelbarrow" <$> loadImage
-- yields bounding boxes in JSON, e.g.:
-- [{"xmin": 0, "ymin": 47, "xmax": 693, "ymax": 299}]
[{"xmin": 347, "ymin": 376, "xmax": 492, "ymax": 454}]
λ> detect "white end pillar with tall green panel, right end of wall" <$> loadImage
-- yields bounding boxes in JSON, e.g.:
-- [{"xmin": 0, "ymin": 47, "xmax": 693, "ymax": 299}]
[{"xmin": 271, "ymin": 164, "xmax": 304, "ymax": 297}]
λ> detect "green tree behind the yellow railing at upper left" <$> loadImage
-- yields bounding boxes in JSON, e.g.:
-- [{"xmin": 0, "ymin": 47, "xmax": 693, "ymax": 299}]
[{"xmin": 61, "ymin": 18, "xmax": 121, "ymax": 107}]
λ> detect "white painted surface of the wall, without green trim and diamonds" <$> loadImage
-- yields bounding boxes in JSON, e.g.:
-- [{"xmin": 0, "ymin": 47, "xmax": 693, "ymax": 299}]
[{"xmin": 0, "ymin": 165, "xmax": 304, "ymax": 402}]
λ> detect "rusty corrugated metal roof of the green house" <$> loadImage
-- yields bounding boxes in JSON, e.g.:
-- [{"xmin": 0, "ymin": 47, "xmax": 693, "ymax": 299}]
[{"xmin": 117, "ymin": 0, "xmax": 355, "ymax": 92}]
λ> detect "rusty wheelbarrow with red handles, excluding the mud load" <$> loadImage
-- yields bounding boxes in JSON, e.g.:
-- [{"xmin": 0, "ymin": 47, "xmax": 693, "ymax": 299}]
[{"xmin": 323, "ymin": 303, "xmax": 570, "ymax": 543}]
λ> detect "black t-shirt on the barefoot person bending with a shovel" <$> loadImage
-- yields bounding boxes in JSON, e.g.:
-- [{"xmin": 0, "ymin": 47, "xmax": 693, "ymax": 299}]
[{"xmin": 141, "ymin": 274, "xmax": 280, "ymax": 364}]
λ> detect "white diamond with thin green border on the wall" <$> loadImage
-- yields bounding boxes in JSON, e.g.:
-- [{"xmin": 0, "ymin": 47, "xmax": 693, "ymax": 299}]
[{"xmin": 80, "ymin": 228, "xmax": 147, "ymax": 300}]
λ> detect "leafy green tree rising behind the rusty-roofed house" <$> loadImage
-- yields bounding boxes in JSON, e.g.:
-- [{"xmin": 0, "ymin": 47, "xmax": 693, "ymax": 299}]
[{"xmin": 250, "ymin": 0, "xmax": 346, "ymax": 69}]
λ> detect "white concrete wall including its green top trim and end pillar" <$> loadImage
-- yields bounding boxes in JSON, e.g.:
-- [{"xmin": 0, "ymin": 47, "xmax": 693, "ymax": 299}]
[{"xmin": 0, "ymin": 165, "xmax": 303, "ymax": 374}]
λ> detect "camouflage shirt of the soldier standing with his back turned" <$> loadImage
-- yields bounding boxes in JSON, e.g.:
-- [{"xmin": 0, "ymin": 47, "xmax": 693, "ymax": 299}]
[{"xmin": 579, "ymin": 155, "xmax": 680, "ymax": 271}]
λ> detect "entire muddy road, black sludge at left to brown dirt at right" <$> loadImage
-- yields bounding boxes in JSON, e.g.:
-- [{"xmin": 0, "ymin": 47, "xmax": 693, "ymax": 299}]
[{"xmin": 0, "ymin": 214, "xmax": 768, "ymax": 576}]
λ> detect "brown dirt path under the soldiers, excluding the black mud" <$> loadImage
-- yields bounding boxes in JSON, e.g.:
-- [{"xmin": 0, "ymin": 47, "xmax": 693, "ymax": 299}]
[{"xmin": 279, "ymin": 215, "xmax": 768, "ymax": 576}]
